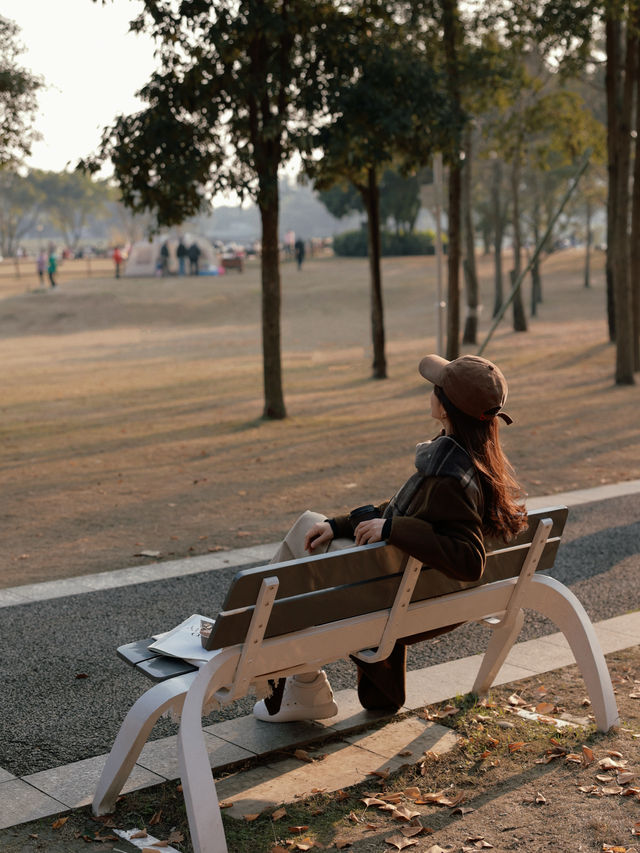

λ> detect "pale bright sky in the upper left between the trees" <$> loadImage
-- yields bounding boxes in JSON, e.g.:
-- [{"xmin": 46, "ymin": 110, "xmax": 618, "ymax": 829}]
[{"xmin": 0, "ymin": 0, "xmax": 156, "ymax": 171}]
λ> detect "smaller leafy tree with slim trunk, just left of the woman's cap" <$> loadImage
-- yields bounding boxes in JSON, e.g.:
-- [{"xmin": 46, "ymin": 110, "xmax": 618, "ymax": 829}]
[{"xmin": 306, "ymin": 24, "xmax": 463, "ymax": 379}]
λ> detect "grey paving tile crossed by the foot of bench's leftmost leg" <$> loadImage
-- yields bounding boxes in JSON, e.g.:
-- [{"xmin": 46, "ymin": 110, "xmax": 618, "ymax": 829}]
[{"xmin": 23, "ymin": 755, "xmax": 165, "ymax": 808}]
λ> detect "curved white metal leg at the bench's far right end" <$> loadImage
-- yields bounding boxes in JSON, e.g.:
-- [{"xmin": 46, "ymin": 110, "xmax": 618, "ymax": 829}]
[{"xmin": 527, "ymin": 575, "xmax": 620, "ymax": 732}]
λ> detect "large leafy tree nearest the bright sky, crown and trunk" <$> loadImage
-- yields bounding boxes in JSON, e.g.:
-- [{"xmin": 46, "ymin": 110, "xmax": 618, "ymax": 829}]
[{"xmin": 87, "ymin": 0, "xmax": 352, "ymax": 418}]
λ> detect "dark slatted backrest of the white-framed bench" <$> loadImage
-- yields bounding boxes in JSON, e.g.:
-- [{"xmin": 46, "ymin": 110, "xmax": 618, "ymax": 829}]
[{"xmin": 207, "ymin": 507, "xmax": 568, "ymax": 649}]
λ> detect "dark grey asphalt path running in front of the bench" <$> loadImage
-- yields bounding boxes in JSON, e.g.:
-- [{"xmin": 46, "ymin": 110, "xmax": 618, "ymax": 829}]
[{"xmin": 0, "ymin": 495, "xmax": 640, "ymax": 776}]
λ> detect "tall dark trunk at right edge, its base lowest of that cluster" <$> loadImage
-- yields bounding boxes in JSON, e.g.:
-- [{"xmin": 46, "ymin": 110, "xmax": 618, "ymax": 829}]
[{"xmin": 613, "ymin": 13, "xmax": 638, "ymax": 385}]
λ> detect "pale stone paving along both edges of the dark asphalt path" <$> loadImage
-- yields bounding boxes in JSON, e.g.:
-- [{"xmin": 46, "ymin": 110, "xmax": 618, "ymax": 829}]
[{"xmin": 0, "ymin": 481, "xmax": 640, "ymax": 829}]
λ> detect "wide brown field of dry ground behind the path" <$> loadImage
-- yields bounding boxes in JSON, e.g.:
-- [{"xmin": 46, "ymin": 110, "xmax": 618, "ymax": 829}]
[{"xmin": 0, "ymin": 250, "xmax": 640, "ymax": 587}]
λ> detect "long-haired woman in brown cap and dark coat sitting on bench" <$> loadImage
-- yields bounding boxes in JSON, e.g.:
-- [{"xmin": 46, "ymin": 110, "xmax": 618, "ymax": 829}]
[{"xmin": 253, "ymin": 355, "xmax": 526, "ymax": 723}]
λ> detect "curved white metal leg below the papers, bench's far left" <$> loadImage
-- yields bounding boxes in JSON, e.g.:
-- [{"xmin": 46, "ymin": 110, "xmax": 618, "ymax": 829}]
[{"xmin": 92, "ymin": 673, "xmax": 196, "ymax": 815}]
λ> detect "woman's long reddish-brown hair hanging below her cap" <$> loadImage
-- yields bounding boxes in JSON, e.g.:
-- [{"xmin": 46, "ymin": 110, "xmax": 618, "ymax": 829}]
[{"xmin": 434, "ymin": 385, "xmax": 527, "ymax": 541}]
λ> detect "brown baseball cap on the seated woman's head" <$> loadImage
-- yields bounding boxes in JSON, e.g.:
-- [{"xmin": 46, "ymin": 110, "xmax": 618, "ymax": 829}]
[{"xmin": 418, "ymin": 355, "xmax": 513, "ymax": 424}]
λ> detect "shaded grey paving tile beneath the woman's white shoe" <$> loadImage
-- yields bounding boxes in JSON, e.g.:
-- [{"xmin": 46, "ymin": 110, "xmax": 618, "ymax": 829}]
[{"xmin": 203, "ymin": 714, "xmax": 326, "ymax": 755}]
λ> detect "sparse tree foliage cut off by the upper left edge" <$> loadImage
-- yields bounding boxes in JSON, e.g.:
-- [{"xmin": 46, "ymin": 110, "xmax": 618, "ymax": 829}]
[{"xmin": 0, "ymin": 16, "xmax": 42, "ymax": 168}]
